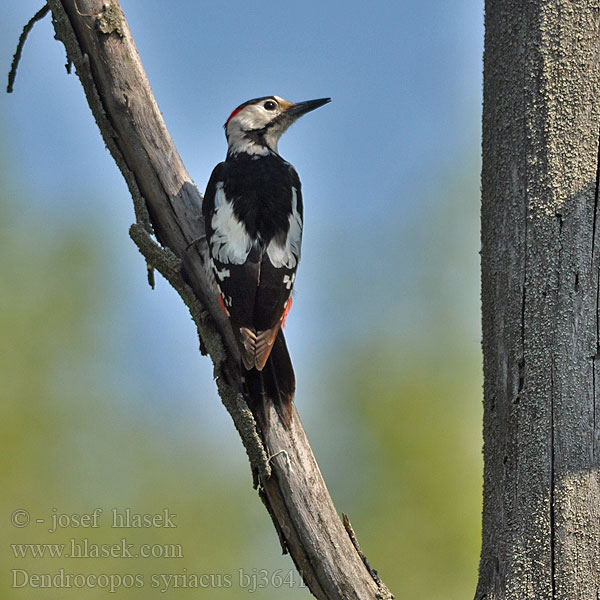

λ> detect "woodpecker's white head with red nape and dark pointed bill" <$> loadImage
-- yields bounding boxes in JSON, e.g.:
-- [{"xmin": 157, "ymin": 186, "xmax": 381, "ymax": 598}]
[{"xmin": 225, "ymin": 96, "xmax": 331, "ymax": 156}]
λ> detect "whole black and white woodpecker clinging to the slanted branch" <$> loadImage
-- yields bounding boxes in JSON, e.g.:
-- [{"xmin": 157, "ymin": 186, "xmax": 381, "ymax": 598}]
[{"xmin": 202, "ymin": 96, "xmax": 330, "ymax": 426}]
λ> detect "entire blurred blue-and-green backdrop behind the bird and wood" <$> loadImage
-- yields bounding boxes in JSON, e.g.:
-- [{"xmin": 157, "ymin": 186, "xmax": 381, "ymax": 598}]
[{"xmin": 0, "ymin": 0, "xmax": 483, "ymax": 600}]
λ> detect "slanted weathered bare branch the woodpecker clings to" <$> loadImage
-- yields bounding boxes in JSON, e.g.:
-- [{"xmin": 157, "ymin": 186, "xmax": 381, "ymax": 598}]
[{"xmin": 39, "ymin": 0, "xmax": 393, "ymax": 600}]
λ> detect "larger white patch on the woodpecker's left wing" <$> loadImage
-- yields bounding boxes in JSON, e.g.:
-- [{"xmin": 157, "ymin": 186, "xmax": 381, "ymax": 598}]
[{"xmin": 210, "ymin": 181, "xmax": 252, "ymax": 264}]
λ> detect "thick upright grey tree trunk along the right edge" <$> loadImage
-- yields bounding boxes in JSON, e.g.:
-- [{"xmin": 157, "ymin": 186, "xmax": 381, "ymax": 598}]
[{"xmin": 476, "ymin": 0, "xmax": 600, "ymax": 600}]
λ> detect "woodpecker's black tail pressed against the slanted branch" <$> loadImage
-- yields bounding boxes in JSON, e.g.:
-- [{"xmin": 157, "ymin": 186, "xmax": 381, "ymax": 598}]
[{"xmin": 242, "ymin": 330, "xmax": 296, "ymax": 429}]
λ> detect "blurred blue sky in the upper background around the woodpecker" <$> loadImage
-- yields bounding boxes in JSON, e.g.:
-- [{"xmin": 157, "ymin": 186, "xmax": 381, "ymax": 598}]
[{"xmin": 0, "ymin": 0, "xmax": 483, "ymax": 426}]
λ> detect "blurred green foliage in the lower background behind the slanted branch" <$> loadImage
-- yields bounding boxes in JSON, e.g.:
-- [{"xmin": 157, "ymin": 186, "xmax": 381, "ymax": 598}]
[{"xmin": 0, "ymin": 154, "xmax": 481, "ymax": 600}]
